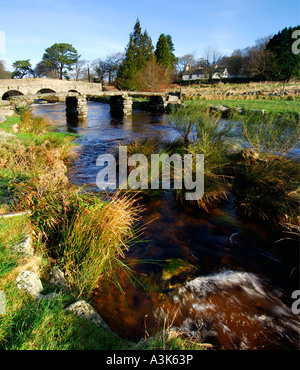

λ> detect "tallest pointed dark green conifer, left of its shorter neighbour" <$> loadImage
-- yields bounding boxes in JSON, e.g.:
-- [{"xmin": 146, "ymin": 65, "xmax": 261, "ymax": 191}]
[{"xmin": 117, "ymin": 19, "xmax": 153, "ymax": 90}]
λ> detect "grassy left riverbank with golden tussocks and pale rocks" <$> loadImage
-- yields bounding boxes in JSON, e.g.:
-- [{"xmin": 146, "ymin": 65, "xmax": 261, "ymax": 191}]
[{"xmin": 0, "ymin": 112, "xmax": 207, "ymax": 350}]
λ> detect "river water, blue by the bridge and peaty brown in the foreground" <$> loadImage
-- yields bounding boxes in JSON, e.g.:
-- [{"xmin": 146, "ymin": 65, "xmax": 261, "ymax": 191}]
[{"xmin": 33, "ymin": 102, "xmax": 300, "ymax": 349}]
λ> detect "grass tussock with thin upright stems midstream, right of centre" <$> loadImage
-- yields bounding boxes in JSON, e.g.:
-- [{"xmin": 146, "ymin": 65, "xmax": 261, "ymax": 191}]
[{"xmin": 171, "ymin": 105, "xmax": 234, "ymax": 211}]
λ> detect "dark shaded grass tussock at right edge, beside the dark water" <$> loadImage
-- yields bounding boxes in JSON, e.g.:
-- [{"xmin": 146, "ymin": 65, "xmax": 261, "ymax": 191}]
[{"xmin": 234, "ymin": 156, "xmax": 300, "ymax": 227}]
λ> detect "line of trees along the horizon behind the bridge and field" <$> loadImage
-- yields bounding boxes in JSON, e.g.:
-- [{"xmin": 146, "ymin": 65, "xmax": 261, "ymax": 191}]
[{"xmin": 0, "ymin": 19, "xmax": 300, "ymax": 91}]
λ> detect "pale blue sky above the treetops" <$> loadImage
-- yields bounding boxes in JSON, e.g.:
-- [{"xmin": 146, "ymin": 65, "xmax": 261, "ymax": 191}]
[{"xmin": 0, "ymin": 0, "xmax": 300, "ymax": 69}]
